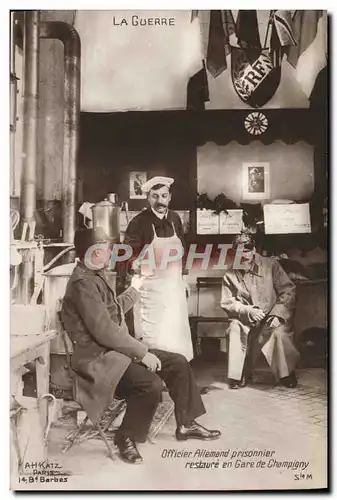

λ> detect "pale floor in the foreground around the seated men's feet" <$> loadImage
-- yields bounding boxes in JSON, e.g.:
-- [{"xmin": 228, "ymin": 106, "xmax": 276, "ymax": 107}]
[{"xmin": 12, "ymin": 363, "xmax": 327, "ymax": 490}]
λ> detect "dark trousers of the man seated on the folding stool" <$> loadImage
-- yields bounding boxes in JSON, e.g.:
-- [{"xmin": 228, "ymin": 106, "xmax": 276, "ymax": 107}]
[{"xmin": 116, "ymin": 349, "xmax": 206, "ymax": 442}]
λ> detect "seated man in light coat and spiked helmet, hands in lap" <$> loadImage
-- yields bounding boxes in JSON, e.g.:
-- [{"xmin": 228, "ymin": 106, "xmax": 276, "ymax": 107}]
[{"xmin": 221, "ymin": 233, "xmax": 299, "ymax": 389}]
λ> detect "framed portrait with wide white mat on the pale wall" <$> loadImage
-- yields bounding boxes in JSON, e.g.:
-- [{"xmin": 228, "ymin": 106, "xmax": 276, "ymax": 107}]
[{"xmin": 242, "ymin": 162, "xmax": 269, "ymax": 200}]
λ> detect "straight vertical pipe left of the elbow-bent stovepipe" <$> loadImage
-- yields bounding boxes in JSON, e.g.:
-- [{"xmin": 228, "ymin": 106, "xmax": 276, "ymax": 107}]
[{"xmin": 20, "ymin": 10, "xmax": 40, "ymax": 229}]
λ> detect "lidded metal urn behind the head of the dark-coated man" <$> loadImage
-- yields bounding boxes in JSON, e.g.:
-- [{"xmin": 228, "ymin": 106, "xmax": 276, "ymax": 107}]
[{"xmin": 91, "ymin": 193, "xmax": 120, "ymax": 243}]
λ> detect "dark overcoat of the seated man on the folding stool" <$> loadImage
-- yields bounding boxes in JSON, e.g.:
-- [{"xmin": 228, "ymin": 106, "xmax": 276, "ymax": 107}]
[{"xmin": 62, "ymin": 262, "xmax": 147, "ymax": 423}]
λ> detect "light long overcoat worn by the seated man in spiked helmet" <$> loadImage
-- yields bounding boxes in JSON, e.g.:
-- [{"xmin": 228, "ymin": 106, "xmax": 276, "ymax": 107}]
[{"xmin": 221, "ymin": 254, "xmax": 299, "ymax": 380}]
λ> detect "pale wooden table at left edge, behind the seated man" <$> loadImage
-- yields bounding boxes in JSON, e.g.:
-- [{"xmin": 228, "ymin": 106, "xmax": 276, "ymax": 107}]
[{"xmin": 11, "ymin": 330, "xmax": 58, "ymax": 427}]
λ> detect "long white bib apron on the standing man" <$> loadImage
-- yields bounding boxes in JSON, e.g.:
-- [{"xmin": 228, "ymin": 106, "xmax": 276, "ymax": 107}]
[{"xmin": 134, "ymin": 224, "xmax": 193, "ymax": 361}]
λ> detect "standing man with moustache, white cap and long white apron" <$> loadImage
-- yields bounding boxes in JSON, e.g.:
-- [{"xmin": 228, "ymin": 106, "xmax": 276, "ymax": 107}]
[{"xmin": 124, "ymin": 177, "xmax": 193, "ymax": 361}]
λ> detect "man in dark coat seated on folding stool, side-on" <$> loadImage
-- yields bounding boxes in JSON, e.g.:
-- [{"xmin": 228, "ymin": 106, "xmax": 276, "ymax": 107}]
[{"xmin": 62, "ymin": 228, "xmax": 220, "ymax": 463}]
